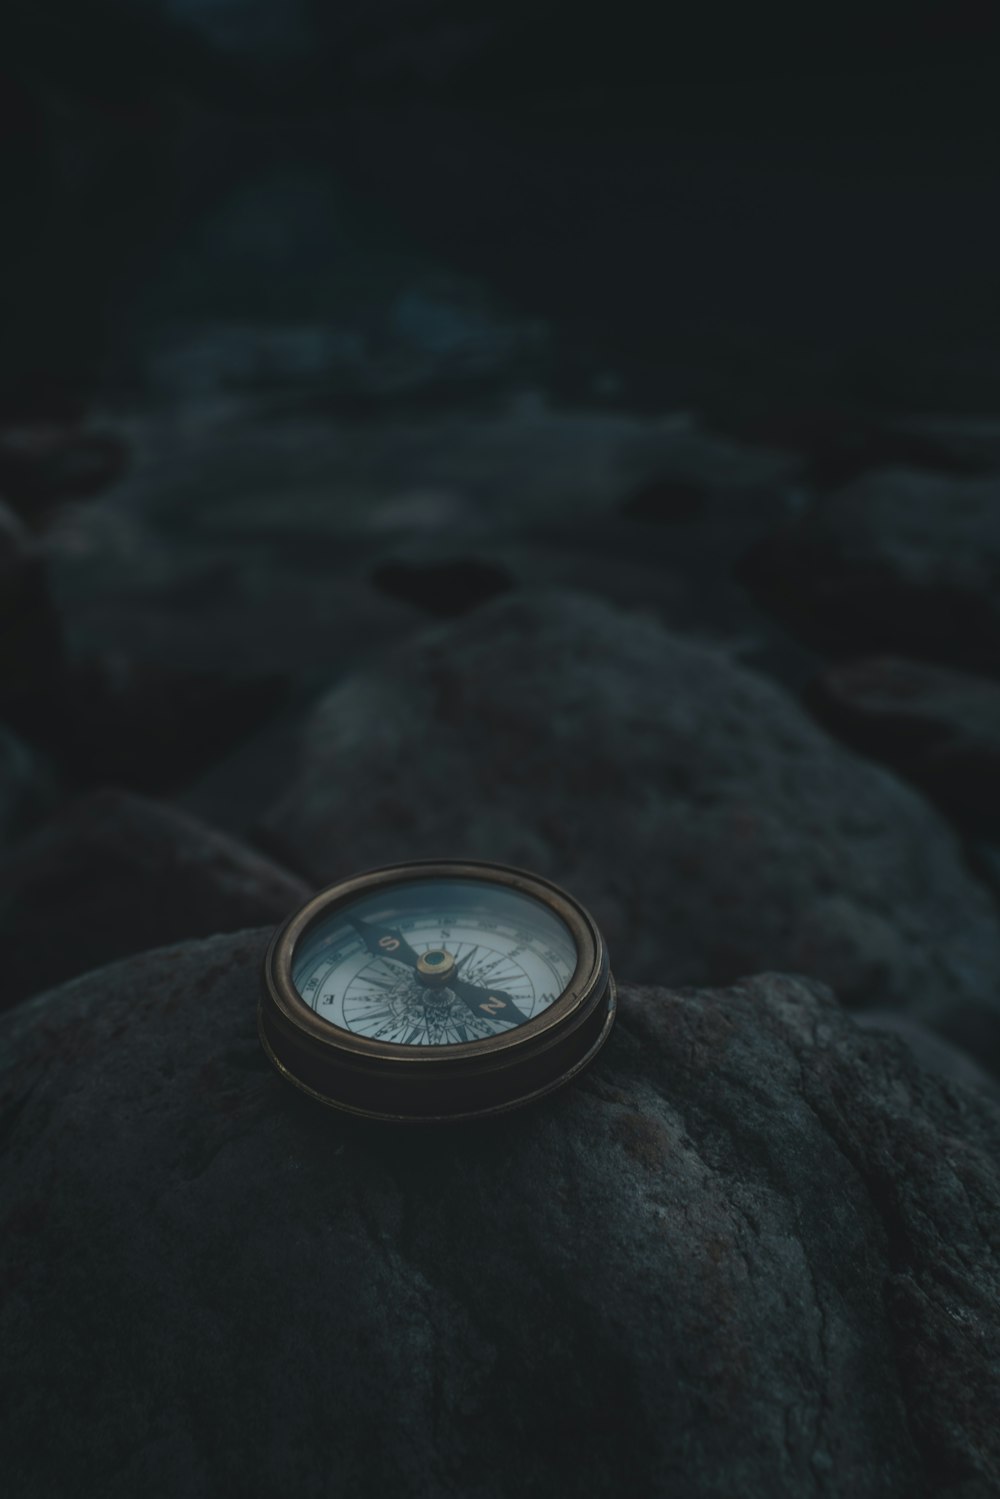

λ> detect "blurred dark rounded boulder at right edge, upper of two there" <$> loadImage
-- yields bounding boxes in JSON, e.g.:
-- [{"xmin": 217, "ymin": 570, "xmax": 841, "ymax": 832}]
[{"xmin": 745, "ymin": 468, "xmax": 1000, "ymax": 670}]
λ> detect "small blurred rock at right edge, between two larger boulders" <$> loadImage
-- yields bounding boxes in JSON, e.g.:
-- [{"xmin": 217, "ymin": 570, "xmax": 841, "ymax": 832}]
[{"xmin": 808, "ymin": 657, "xmax": 1000, "ymax": 833}]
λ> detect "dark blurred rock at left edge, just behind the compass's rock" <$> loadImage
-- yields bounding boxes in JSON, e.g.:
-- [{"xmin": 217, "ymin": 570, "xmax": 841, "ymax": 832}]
[{"xmin": 0, "ymin": 790, "xmax": 309, "ymax": 1009}]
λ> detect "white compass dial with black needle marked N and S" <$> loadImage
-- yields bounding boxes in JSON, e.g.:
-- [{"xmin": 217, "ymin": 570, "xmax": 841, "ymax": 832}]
[{"xmin": 292, "ymin": 878, "xmax": 577, "ymax": 1046}]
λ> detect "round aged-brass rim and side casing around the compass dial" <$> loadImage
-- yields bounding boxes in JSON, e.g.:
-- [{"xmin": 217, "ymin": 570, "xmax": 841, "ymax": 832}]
[{"xmin": 258, "ymin": 859, "xmax": 616, "ymax": 1121}]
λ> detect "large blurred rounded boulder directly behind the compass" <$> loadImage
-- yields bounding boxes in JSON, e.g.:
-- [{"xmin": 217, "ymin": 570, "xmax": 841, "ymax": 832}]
[{"xmin": 267, "ymin": 595, "xmax": 1000, "ymax": 1057}]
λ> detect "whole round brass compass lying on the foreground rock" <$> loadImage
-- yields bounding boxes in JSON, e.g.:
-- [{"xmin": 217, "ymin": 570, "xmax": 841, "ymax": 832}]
[{"xmin": 258, "ymin": 860, "xmax": 616, "ymax": 1121}]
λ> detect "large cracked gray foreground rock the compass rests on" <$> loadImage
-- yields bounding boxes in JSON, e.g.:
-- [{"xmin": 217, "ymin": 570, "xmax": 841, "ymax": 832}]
[{"xmin": 0, "ymin": 932, "xmax": 1000, "ymax": 1499}]
